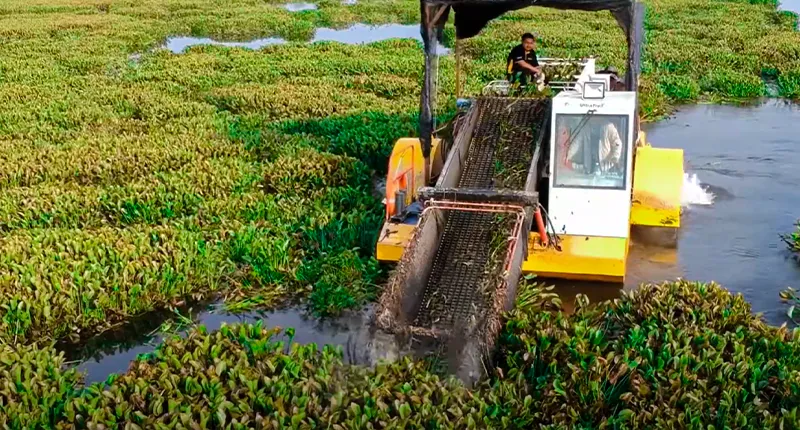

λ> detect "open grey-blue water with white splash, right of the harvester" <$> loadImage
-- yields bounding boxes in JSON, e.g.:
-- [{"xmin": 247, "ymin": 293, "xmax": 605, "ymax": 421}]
[{"xmin": 558, "ymin": 101, "xmax": 800, "ymax": 324}]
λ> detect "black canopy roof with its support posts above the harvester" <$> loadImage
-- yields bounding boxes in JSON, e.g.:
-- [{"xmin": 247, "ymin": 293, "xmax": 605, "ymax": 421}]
[{"xmin": 419, "ymin": 0, "xmax": 644, "ymax": 165}]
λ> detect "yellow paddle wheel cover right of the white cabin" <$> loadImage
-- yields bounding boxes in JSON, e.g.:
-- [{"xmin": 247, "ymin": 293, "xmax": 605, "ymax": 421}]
[{"xmin": 630, "ymin": 144, "xmax": 683, "ymax": 228}]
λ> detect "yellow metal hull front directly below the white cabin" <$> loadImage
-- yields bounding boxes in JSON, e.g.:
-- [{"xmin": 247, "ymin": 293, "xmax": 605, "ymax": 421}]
[{"xmin": 522, "ymin": 233, "xmax": 628, "ymax": 282}]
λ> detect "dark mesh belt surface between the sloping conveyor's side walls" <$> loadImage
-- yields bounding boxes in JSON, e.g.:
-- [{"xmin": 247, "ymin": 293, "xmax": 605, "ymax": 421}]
[{"xmin": 414, "ymin": 98, "xmax": 545, "ymax": 328}]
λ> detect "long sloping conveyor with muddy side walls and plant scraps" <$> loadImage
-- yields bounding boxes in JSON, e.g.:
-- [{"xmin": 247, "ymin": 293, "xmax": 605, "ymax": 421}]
[{"xmin": 378, "ymin": 97, "xmax": 549, "ymax": 383}]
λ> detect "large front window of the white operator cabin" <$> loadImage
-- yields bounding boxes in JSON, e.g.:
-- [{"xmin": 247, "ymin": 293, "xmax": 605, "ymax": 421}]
[{"xmin": 553, "ymin": 114, "xmax": 628, "ymax": 190}]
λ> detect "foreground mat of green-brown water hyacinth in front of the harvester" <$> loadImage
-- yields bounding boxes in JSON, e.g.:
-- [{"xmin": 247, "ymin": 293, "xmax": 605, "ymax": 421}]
[{"xmin": 0, "ymin": 282, "xmax": 800, "ymax": 429}]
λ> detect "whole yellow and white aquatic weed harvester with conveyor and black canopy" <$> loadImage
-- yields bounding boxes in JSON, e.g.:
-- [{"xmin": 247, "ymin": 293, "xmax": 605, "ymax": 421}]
[{"xmin": 376, "ymin": 0, "xmax": 683, "ymax": 383}]
